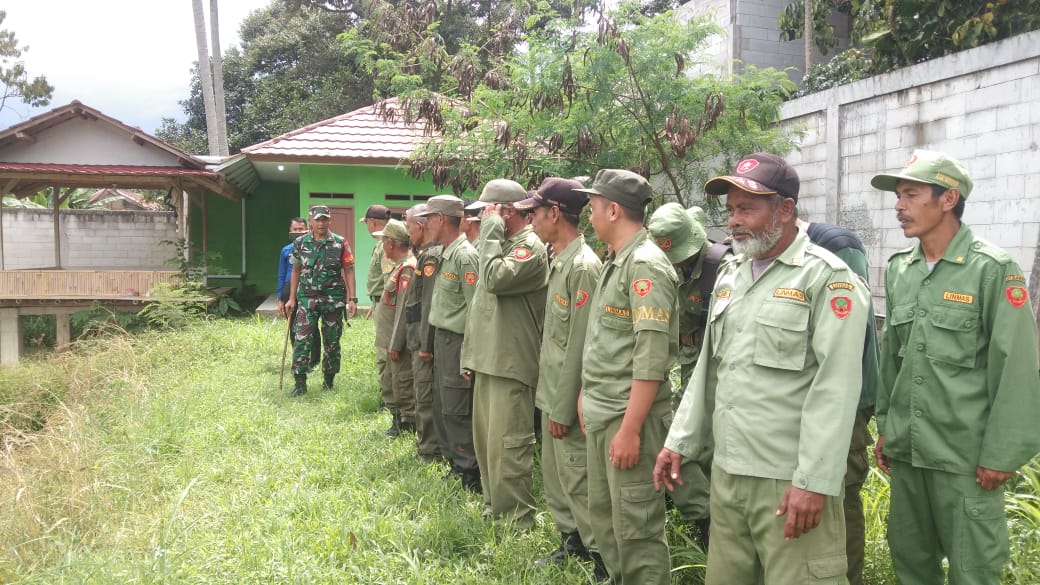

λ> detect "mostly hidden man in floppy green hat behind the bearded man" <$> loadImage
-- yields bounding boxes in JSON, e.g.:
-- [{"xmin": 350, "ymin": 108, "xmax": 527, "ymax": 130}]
[{"xmin": 647, "ymin": 203, "xmax": 713, "ymax": 551}]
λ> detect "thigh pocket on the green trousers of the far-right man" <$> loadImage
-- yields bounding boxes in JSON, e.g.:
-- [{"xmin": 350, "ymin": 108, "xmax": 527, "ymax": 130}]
[{"xmin": 959, "ymin": 489, "xmax": 1011, "ymax": 570}]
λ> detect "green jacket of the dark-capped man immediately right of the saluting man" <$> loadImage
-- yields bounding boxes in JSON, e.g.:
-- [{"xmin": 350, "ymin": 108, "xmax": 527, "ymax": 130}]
[{"xmin": 535, "ymin": 234, "xmax": 603, "ymax": 427}]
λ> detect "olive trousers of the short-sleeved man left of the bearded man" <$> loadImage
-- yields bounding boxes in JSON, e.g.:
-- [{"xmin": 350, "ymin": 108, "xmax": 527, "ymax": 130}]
[{"xmin": 586, "ymin": 404, "xmax": 672, "ymax": 585}]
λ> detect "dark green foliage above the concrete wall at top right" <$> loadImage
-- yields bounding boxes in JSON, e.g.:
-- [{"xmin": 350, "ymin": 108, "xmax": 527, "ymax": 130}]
[{"xmin": 779, "ymin": 0, "xmax": 1040, "ymax": 81}]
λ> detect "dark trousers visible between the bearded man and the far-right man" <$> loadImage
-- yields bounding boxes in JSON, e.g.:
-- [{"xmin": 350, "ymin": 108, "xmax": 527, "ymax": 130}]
[{"xmin": 844, "ymin": 409, "xmax": 874, "ymax": 585}]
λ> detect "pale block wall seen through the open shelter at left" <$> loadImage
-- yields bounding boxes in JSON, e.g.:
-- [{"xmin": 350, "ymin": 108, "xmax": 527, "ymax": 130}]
[{"xmin": 3, "ymin": 208, "xmax": 177, "ymax": 270}]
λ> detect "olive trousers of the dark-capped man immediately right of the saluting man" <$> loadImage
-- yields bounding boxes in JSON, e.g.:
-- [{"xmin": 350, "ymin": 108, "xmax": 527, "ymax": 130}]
[{"xmin": 542, "ymin": 412, "xmax": 598, "ymax": 551}]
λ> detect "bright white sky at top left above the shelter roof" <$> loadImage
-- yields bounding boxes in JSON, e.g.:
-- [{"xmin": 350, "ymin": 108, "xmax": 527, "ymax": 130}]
[{"xmin": 0, "ymin": 0, "xmax": 269, "ymax": 134}]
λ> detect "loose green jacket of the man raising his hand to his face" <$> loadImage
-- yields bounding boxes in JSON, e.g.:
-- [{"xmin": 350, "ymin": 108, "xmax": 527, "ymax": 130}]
[{"xmin": 462, "ymin": 215, "xmax": 549, "ymax": 387}]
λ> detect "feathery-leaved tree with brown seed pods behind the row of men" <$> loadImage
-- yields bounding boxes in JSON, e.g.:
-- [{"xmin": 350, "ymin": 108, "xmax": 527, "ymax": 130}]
[{"xmin": 397, "ymin": 6, "xmax": 795, "ymax": 204}]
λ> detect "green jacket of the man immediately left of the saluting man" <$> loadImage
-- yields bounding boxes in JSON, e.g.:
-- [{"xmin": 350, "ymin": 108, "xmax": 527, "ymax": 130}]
[{"xmin": 430, "ymin": 234, "xmax": 479, "ymax": 335}]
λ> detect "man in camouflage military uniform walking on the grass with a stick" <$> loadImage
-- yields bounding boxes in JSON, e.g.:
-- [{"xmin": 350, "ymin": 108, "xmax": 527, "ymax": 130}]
[{"xmin": 285, "ymin": 205, "xmax": 358, "ymax": 397}]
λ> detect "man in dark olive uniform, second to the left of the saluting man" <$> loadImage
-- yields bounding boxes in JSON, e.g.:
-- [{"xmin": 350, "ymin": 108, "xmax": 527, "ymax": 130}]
[{"xmin": 391, "ymin": 203, "xmax": 443, "ymax": 461}]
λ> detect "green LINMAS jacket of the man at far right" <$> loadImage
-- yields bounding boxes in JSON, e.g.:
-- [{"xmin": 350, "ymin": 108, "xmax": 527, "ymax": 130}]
[{"xmin": 878, "ymin": 225, "xmax": 1040, "ymax": 475}]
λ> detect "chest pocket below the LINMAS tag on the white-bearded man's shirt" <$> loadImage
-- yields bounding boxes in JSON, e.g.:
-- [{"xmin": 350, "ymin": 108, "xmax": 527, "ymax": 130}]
[{"xmin": 754, "ymin": 303, "xmax": 811, "ymax": 371}]
